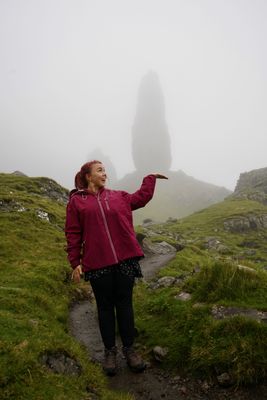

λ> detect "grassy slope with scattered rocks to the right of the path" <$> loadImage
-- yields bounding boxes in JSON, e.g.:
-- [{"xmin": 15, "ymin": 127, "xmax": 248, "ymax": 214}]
[{"xmin": 136, "ymin": 199, "xmax": 267, "ymax": 384}]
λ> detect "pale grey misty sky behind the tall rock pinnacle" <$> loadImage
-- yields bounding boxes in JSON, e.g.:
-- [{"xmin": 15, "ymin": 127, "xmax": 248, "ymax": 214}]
[{"xmin": 0, "ymin": 0, "xmax": 267, "ymax": 189}]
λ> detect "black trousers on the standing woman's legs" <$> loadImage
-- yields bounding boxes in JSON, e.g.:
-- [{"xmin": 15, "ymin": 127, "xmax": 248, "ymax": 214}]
[{"xmin": 90, "ymin": 269, "xmax": 134, "ymax": 349}]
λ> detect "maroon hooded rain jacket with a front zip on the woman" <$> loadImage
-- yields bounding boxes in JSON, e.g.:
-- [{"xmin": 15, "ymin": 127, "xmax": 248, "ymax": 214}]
[{"xmin": 65, "ymin": 175, "xmax": 156, "ymax": 272}]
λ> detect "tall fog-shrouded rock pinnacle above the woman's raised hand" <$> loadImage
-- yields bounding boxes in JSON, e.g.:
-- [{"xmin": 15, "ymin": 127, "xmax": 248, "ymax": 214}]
[{"xmin": 132, "ymin": 71, "xmax": 171, "ymax": 174}]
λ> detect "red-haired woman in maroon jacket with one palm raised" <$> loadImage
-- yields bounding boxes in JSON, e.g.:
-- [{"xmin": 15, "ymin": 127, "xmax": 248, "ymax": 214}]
[{"xmin": 65, "ymin": 160, "xmax": 167, "ymax": 375}]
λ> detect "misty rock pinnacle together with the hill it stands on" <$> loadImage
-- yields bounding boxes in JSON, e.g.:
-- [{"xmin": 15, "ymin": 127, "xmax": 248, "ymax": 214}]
[{"xmin": 113, "ymin": 72, "xmax": 231, "ymax": 224}]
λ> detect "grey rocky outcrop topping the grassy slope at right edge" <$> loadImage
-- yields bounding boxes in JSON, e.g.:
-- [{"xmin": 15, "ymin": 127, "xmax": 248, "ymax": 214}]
[{"xmin": 233, "ymin": 168, "xmax": 267, "ymax": 204}]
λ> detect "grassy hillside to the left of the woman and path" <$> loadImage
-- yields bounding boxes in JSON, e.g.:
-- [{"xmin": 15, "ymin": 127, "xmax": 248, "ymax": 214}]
[{"xmin": 0, "ymin": 174, "xmax": 132, "ymax": 400}]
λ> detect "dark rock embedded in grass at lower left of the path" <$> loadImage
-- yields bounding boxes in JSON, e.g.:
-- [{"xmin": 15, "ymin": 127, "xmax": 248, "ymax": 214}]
[{"xmin": 40, "ymin": 352, "xmax": 82, "ymax": 375}]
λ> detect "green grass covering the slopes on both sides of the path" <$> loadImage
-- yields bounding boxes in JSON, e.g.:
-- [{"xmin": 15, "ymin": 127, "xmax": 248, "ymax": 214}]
[{"xmin": 0, "ymin": 174, "xmax": 267, "ymax": 390}]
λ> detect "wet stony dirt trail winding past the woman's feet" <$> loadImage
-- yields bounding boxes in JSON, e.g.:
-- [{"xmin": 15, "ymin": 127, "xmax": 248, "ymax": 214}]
[{"xmin": 69, "ymin": 252, "xmax": 267, "ymax": 400}]
